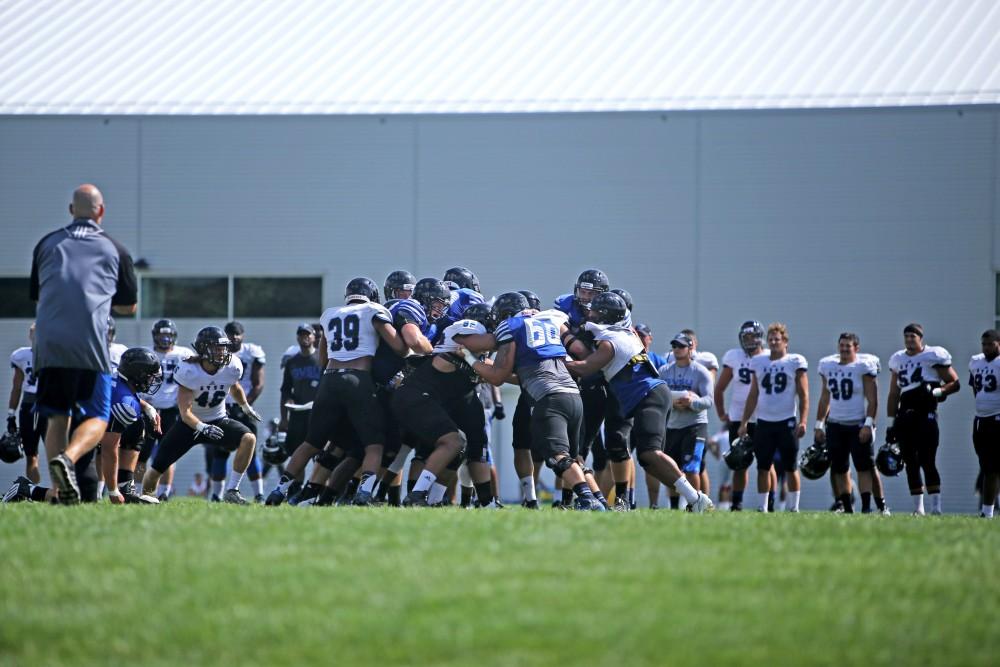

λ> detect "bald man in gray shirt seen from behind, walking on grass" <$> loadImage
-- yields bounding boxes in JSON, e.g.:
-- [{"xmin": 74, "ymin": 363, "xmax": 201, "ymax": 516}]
[{"xmin": 31, "ymin": 184, "xmax": 136, "ymax": 504}]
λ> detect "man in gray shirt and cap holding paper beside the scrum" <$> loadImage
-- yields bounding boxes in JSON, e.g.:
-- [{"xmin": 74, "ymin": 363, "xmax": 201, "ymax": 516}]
[{"xmin": 659, "ymin": 333, "xmax": 715, "ymax": 507}]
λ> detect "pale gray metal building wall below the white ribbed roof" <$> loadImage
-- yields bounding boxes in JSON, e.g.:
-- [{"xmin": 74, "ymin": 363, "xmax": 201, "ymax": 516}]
[{"xmin": 0, "ymin": 108, "xmax": 1000, "ymax": 511}]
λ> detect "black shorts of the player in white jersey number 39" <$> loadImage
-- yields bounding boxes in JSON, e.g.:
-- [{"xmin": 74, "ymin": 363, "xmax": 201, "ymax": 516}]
[{"xmin": 306, "ymin": 368, "xmax": 385, "ymax": 448}]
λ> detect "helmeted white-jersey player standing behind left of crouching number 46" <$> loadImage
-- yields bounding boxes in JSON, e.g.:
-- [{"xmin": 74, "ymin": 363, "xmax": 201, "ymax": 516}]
[{"xmin": 139, "ymin": 319, "xmax": 197, "ymax": 501}]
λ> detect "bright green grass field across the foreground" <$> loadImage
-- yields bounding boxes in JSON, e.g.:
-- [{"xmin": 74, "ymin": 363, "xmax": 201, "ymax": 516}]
[{"xmin": 0, "ymin": 501, "xmax": 1000, "ymax": 667}]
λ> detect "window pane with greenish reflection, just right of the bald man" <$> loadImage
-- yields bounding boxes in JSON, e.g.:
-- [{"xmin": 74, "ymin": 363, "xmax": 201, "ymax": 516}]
[{"xmin": 139, "ymin": 277, "xmax": 229, "ymax": 319}]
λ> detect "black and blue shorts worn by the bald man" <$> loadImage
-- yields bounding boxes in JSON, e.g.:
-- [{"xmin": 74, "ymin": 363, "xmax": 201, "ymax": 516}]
[{"xmin": 35, "ymin": 368, "xmax": 114, "ymax": 421}]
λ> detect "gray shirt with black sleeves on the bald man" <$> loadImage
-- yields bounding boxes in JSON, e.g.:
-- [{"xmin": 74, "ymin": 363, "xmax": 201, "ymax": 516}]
[{"xmin": 30, "ymin": 218, "xmax": 136, "ymax": 373}]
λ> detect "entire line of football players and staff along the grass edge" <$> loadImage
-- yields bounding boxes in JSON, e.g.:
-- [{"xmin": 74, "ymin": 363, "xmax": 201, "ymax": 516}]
[{"xmin": 0, "ymin": 267, "xmax": 1000, "ymax": 516}]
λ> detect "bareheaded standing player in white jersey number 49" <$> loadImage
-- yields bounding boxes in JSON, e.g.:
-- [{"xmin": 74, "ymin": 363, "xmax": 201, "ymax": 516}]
[{"xmin": 738, "ymin": 322, "xmax": 809, "ymax": 512}]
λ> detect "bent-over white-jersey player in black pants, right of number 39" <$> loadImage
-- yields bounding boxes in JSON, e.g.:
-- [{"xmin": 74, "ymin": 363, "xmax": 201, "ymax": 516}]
[{"xmin": 392, "ymin": 303, "xmax": 502, "ymax": 509}]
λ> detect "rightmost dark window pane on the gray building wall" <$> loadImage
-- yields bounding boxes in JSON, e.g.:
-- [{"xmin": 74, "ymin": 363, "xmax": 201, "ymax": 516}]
[{"xmin": 233, "ymin": 277, "xmax": 323, "ymax": 318}]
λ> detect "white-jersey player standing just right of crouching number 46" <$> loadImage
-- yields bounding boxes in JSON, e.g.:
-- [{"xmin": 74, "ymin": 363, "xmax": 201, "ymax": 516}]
[{"xmin": 219, "ymin": 320, "xmax": 267, "ymax": 503}]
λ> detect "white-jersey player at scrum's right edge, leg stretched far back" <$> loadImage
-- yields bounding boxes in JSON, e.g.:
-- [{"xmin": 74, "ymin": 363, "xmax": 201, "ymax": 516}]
[{"xmin": 563, "ymin": 292, "xmax": 713, "ymax": 512}]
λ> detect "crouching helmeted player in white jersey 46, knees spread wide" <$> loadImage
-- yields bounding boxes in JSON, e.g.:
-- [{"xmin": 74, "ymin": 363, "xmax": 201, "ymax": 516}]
[{"xmin": 142, "ymin": 327, "xmax": 260, "ymax": 505}]
